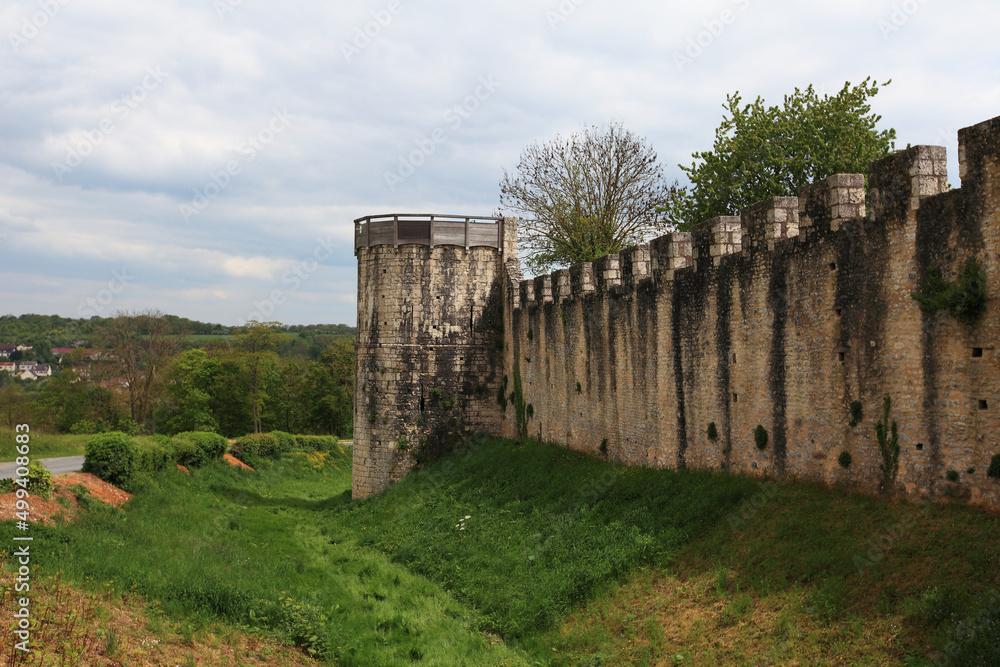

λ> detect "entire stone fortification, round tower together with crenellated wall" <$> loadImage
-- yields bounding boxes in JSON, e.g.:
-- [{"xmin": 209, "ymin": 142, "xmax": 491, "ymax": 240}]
[{"xmin": 354, "ymin": 117, "xmax": 1000, "ymax": 508}]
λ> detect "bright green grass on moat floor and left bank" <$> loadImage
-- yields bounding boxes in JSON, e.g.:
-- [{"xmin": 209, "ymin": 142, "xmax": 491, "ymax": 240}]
[{"xmin": 0, "ymin": 448, "xmax": 524, "ymax": 665}]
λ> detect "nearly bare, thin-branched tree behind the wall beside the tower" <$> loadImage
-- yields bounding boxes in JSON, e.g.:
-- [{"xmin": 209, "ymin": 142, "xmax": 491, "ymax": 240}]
[{"xmin": 500, "ymin": 123, "xmax": 682, "ymax": 271}]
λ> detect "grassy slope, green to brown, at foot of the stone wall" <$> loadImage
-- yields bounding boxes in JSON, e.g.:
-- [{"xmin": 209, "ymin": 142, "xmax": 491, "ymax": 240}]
[{"xmin": 339, "ymin": 443, "xmax": 1000, "ymax": 665}]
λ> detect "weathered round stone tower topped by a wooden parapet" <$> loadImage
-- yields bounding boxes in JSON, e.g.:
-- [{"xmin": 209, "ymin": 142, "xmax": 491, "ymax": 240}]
[{"xmin": 352, "ymin": 214, "xmax": 517, "ymax": 498}]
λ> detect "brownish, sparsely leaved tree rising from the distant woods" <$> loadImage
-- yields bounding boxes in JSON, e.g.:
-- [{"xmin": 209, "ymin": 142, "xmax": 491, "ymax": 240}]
[{"xmin": 100, "ymin": 310, "xmax": 177, "ymax": 424}]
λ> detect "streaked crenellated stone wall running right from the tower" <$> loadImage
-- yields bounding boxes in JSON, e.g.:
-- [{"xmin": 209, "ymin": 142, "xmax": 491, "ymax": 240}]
[{"xmin": 504, "ymin": 119, "xmax": 1000, "ymax": 507}]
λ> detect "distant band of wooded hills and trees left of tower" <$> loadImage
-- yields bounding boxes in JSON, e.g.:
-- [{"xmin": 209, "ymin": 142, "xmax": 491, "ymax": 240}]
[{"xmin": 0, "ymin": 311, "xmax": 354, "ymax": 437}]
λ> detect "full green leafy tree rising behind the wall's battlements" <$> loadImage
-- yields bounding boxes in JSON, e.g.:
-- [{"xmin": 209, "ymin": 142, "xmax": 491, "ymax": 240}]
[{"xmin": 668, "ymin": 77, "xmax": 896, "ymax": 229}]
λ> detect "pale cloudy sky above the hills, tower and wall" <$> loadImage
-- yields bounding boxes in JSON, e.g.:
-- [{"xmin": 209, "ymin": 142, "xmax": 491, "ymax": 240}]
[{"xmin": 0, "ymin": 0, "xmax": 1000, "ymax": 325}]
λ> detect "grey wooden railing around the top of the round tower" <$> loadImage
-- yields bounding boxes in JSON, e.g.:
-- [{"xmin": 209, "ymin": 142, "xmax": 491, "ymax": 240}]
[{"xmin": 354, "ymin": 213, "xmax": 503, "ymax": 254}]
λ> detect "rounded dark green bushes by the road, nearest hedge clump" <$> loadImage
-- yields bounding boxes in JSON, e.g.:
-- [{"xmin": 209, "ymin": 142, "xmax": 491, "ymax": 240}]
[{"xmin": 83, "ymin": 431, "xmax": 227, "ymax": 490}]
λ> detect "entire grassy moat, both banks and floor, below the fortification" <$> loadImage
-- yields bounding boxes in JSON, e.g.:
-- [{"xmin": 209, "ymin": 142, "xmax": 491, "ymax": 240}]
[{"xmin": 0, "ymin": 439, "xmax": 1000, "ymax": 665}]
